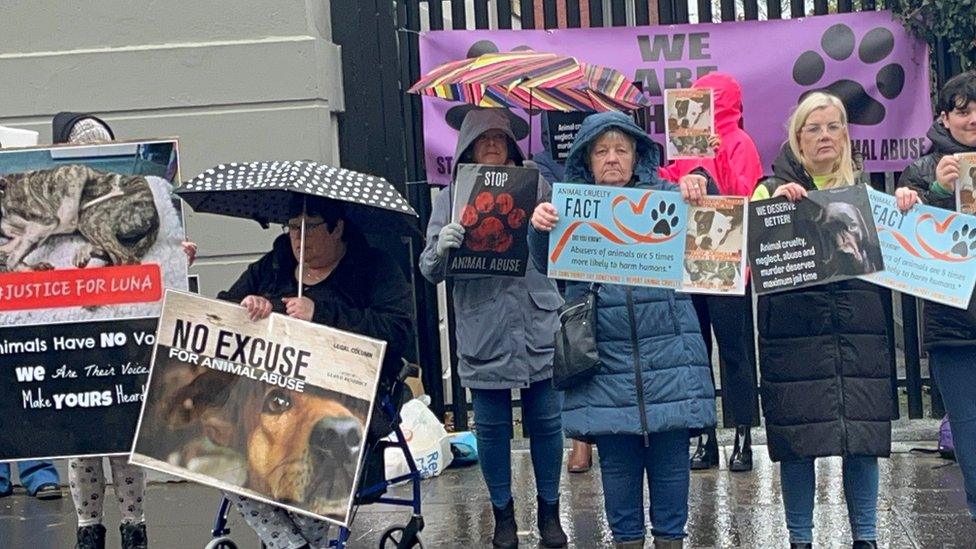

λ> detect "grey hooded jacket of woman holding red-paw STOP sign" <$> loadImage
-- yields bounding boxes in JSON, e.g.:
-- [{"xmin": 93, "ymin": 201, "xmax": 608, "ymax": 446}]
[{"xmin": 420, "ymin": 109, "xmax": 563, "ymax": 389}]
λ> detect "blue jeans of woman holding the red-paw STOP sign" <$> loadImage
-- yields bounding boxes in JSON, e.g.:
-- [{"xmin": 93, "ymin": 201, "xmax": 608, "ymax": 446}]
[{"xmin": 471, "ymin": 379, "xmax": 563, "ymax": 507}]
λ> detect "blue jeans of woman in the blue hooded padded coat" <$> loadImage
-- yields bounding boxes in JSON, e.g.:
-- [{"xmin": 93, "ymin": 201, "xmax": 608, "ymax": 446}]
[{"xmin": 596, "ymin": 429, "xmax": 691, "ymax": 542}]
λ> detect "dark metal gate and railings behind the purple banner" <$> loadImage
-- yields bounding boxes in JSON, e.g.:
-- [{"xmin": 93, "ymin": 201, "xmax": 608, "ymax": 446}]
[{"xmin": 332, "ymin": 0, "xmax": 960, "ymax": 430}]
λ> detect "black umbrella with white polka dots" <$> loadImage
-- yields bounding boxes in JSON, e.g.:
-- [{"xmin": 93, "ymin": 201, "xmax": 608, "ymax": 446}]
[{"xmin": 176, "ymin": 161, "xmax": 420, "ymax": 235}]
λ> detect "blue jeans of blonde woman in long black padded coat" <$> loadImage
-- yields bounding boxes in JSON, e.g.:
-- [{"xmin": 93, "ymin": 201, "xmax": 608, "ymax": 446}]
[{"xmin": 779, "ymin": 456, "xmax": 878, "ymax": 543}]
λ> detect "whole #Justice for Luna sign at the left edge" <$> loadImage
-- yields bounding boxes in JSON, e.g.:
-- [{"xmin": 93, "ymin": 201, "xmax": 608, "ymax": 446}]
[{"xmin": 0, "ymin": 139, "xmax": 187, "ymax": 461}]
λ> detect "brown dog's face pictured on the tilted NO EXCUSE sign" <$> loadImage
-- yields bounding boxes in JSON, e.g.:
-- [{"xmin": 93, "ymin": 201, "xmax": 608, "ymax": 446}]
[{"xmin": 168, "ymin": 371, "xmax": 367, "ymax": 515}]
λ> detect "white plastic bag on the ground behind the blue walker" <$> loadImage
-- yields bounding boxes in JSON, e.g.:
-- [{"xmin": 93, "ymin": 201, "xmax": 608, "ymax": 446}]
[{"xmin": 384, "ymin": 398, "xmax": 454, "ymax": 479}]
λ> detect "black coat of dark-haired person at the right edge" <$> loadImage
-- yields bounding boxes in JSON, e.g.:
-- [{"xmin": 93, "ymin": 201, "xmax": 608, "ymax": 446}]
[{"xmin": 898, "ymin": 120, "xmax": 976, "ymax": 349}]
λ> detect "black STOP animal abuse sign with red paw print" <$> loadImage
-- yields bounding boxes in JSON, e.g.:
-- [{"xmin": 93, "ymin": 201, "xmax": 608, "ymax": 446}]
[{"xmin": 447, "ymin": 164, "xmax": 539, "ymax": 276}]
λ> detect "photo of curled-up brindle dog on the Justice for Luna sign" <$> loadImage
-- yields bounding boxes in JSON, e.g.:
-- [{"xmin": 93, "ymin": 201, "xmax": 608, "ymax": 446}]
[{"xmin": 0, "ymin": 140, "xmax": 187, "ymax": 326}]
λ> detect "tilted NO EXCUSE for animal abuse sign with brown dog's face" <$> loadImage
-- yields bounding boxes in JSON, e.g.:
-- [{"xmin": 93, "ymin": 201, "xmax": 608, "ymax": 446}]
[{"xmin": 132, "ymin": 292, "xmax": 386, "ymax": 525}]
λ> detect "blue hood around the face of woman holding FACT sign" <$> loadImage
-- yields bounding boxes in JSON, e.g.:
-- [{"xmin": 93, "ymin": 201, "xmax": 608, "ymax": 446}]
[{"xmin": 565, "ymin": 112, "xmax": 662, "ymax": 186}]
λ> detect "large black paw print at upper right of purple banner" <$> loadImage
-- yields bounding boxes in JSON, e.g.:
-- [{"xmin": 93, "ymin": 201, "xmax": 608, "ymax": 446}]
[{"xmin": 793, "ymin": 23, "xmax": 905, "ymax": 126}]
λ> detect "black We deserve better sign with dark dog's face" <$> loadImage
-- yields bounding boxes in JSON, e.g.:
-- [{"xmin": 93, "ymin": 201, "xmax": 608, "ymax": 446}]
[{"xmin": 748, "ymin": 185, "xmax": 884, "ymax": 294}]
